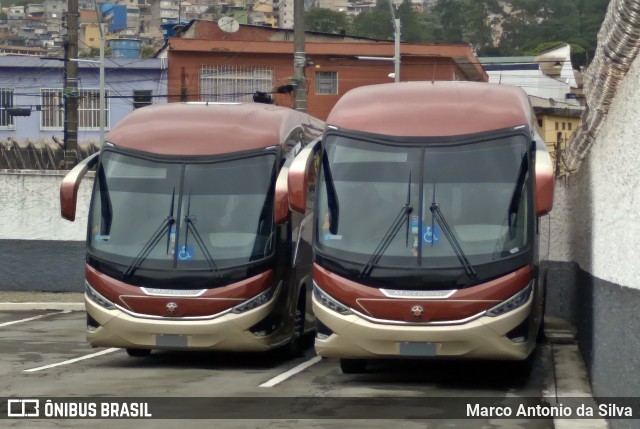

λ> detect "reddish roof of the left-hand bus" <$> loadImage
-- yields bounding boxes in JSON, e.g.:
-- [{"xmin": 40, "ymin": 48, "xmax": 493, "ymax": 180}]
[{"xmin": 106, "ymin": 103, "xmax": 324, "ymax": 156}]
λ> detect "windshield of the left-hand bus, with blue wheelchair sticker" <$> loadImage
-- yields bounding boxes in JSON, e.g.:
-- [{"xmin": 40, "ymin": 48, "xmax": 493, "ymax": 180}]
[{"xmin": 87, "ymin": 150, "xmax": 276, "ymax": 277}]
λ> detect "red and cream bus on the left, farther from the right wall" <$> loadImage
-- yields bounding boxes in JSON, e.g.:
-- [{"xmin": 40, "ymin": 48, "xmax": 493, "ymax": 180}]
[{"xmin": 60, "ymin": 103, "xmax": 324, "ymax": 356}]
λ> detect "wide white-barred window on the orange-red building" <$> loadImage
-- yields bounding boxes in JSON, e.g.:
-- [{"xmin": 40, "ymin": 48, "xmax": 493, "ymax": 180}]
[{"xmin": 200, "ymin": 66, "xmax": 273, "ymax": 102}]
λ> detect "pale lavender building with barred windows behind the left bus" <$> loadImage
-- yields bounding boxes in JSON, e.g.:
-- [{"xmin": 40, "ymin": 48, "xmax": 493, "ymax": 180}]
[{"xmin": 0, "ymin": 56, "xmax": 167, "ymax": 143}]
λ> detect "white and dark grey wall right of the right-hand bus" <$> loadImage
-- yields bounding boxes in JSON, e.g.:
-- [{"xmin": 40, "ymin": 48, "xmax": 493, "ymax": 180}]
[{"xmin": 542, "ymin": 51, "xmax": 640, "ymax": 428}]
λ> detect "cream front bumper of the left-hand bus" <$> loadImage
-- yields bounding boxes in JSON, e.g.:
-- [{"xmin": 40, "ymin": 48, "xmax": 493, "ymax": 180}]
[{"xmin": 85, "ymin": 295, "xmax": 276, "ymax": 351}]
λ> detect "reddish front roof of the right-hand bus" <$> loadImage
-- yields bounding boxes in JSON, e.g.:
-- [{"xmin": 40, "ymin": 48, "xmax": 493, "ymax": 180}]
[{"xmin": 327, "ymin": 81, "xmax": 535, "ymax": 137}]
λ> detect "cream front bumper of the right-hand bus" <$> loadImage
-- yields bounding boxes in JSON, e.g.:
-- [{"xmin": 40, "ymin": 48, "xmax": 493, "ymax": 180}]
[{"xmin": 313, "ymin": 294, "xmax": 535, "ymax": 360}]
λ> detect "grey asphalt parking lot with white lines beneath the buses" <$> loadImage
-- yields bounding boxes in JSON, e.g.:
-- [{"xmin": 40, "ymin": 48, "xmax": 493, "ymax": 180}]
[{"xmin": 0, "ymin": 310, "xmax": 592, "ymax": 428}]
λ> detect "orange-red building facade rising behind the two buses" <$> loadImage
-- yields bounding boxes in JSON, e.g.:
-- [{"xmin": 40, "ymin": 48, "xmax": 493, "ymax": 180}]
[{"xmin": 168, "ymin": 21, "xmax": 488, "ymax": 119}]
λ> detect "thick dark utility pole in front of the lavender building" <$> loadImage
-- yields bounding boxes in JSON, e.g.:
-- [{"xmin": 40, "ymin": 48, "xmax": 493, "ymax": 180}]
[{"xmin": 63, "ymin": 0, "xmax": 78, "ymax": 168}]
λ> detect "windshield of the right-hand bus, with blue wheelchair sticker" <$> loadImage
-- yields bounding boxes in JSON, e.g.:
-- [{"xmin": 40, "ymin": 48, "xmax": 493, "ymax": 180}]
[{"xmin": 316, "ymin": 134, "xmax": 533, "ymax": 275}]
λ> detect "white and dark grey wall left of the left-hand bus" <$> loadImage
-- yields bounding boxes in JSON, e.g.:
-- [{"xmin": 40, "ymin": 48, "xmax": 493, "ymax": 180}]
[{"xmin": 0, "ymin": 171, "xmax": 93, "ymax": 292}]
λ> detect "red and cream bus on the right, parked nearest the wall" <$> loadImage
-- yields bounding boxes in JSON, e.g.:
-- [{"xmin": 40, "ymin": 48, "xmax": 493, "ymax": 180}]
[{"xmin": 289, "ymin": 82, "xmax": 554, "ymax": 373}]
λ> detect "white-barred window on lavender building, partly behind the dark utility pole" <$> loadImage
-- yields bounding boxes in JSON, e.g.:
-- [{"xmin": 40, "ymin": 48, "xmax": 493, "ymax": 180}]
[{"xmin": 40, "ymin": 89, "xmax": 110, "ymax": 131}]
